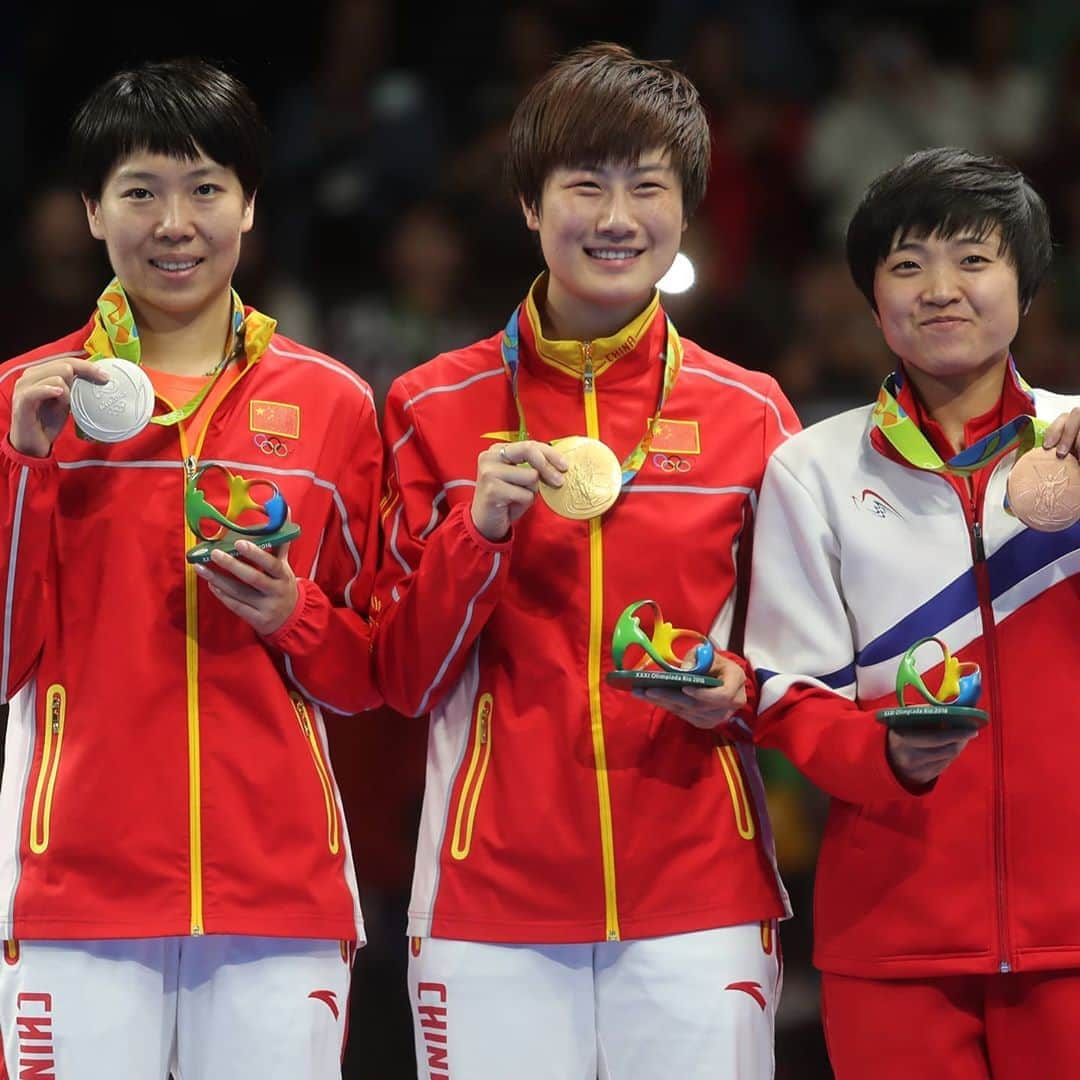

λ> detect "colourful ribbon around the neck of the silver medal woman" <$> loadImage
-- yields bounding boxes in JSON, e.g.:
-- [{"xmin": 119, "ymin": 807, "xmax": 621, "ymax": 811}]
[{"xmin": 83, "ymin": 278, "xmax": 278, "ymax": 427}]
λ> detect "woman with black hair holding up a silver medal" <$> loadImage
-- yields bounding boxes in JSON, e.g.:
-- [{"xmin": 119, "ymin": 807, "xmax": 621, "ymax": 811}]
[{"xmin": 0, "ymin": 59, "xmax": 381, "ymax": 1080}]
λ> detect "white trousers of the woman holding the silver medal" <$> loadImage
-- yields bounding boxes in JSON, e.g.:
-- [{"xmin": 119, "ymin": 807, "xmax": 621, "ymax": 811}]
[{"xmin": 0, "ymin": 934, "xmax": 352, "ymax": 1080}]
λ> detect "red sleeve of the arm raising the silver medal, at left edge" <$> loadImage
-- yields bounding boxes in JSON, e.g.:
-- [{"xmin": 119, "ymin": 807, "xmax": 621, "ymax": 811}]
[{"xmin": 0, "ymin": 395, "xmax": 60, "ymax": 701}]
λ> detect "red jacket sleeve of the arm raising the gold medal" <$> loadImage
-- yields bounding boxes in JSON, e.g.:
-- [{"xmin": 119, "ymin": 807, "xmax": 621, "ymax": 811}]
[{"xmin": 374, "ymin": 379, "xmax": 512, "ymax": 716}]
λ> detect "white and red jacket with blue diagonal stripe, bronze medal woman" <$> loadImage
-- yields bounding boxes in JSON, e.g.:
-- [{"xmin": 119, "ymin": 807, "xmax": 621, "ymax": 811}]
[{"xmin": 746, "ymin": 374, "xmax": 1080, "ymax": 978}]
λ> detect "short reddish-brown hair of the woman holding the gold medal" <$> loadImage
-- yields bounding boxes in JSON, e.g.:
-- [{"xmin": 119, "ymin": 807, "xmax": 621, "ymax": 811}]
[{"xmin": 507, "ymin": 42, "xmax": 712, "ymax": 218}]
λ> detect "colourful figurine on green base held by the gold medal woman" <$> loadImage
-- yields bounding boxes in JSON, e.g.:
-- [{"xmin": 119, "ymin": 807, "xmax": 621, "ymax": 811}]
[{"xmin": 607, "ymin": 600, "xmax": 724, "ymax": 690}]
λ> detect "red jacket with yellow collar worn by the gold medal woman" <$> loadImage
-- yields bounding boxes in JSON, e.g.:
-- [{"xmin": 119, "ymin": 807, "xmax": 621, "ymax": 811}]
[{"xmin": 376, "ymin": 287, "xmax": 798, "ymax": 944}]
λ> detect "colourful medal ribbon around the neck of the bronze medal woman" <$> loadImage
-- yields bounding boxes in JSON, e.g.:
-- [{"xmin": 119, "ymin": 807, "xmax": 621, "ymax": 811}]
[{"xmin": 873, "ymin": 357, "xmax": 1050, "ymax": 476}]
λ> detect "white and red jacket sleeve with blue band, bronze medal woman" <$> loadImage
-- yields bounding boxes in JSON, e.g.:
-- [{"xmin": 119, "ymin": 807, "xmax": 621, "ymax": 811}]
[{"xmin": 746, "ymin": 447, "xmax": 910, "ymax": 804}]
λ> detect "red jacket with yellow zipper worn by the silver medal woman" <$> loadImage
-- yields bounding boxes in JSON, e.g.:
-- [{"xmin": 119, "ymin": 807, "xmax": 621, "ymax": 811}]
[{"xmin": 0, "ymin": 315, "xmax": 381, "ymax": 940}]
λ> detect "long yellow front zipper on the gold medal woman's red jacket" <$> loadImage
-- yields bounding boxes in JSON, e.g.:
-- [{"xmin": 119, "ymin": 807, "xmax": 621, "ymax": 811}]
[{"xmin": 581, "ymin": 341, "xmax": 620, "ymax": 942}]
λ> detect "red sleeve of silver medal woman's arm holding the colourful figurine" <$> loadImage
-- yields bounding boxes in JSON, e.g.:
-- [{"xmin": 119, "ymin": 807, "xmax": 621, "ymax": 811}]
[{"xmin": 266, "ymin": 397, "xmax": 382, "ymax": 714}]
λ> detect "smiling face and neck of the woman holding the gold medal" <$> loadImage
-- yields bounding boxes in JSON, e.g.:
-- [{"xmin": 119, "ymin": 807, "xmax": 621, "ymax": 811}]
[{"xmin": 522, "ymin": 150, "xmax": 686, "ymax": 340}]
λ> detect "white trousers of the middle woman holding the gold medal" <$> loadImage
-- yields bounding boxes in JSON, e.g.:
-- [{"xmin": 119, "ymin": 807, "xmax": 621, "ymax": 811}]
[{"xmin": 408, "ymin": 922, "xmax": 782, "ymax": 1080}]
